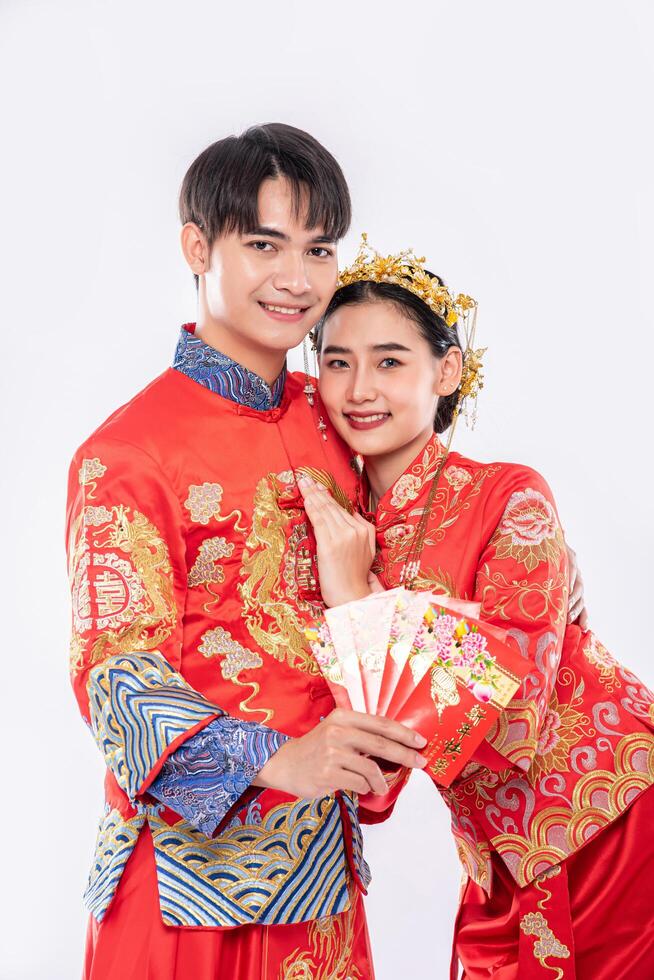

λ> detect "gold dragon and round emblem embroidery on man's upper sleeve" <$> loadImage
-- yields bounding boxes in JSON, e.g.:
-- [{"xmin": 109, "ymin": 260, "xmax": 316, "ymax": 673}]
[{"xmin": 69, "ymin": 506, "xmax": 177, "ymax": 670}]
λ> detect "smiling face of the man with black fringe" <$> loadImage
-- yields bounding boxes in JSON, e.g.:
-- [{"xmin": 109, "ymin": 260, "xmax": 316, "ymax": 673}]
[{"xmin": 200, "ymin": 178, "xmax": 338, "ymax": 356}]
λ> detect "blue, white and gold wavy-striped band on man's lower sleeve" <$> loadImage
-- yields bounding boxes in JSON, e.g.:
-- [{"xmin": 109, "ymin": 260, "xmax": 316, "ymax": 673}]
[{"xmin": 87, "ymin": 650, "xmax": 224, "ymax": 802}]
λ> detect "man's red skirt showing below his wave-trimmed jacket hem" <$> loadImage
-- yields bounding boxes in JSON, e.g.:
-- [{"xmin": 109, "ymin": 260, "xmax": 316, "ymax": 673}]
[{"xmin": 84, "ymin": 828, "xmax": 374, "ymax": 980}]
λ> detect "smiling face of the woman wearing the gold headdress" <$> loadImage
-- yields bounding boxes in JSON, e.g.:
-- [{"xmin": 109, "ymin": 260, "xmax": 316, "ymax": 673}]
[{"xmin": 320, "ymin": 301, "xmax": 461, "ymax": 457}]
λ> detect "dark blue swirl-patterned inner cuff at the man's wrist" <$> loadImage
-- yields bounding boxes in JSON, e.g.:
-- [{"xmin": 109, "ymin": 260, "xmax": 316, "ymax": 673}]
[{"xmin": 148, "ymin": 716, "xmax": 288, "ymax": 837}]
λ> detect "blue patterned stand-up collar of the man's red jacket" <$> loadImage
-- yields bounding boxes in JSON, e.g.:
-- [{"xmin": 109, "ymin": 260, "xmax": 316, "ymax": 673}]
[{"xmin": 173, "ymin": 323, "xmax": 286, "ymax": 412}]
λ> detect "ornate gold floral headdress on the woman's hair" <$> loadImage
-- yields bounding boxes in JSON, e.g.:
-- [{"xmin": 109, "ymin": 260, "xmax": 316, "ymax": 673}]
[{"xmin": 337, "ymin": 232, "xmax": 486, "ymax": 430}]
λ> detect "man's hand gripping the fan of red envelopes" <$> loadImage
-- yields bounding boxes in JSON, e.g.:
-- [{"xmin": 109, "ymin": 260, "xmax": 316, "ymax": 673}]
[{"xmin": 254, "ymin": 708, "xmax": 427, "ymax": 799}]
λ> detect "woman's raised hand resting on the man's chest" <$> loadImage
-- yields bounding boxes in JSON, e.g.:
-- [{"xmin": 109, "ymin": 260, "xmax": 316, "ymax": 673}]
[{"xmin": 297, "ymin": 474, "xmax": 375, "ymax": 606}]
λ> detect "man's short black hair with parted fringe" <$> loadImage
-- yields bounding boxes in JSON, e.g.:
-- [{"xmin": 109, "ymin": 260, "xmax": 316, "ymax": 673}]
[{"xmin": 179, "ymin": 123, "xmax": 352, "ymax": 246}]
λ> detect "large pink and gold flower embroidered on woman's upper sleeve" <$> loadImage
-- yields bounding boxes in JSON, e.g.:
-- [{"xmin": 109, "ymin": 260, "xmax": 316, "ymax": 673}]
[{"xmin": 491, "ymin": 488, "xmax": 563, "ymax": 572}]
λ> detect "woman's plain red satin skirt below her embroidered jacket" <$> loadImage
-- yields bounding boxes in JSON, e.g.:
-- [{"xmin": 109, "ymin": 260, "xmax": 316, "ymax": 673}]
[{"xmin": 452, "ymin": 788, "xmax": 654, "ymax": 980}]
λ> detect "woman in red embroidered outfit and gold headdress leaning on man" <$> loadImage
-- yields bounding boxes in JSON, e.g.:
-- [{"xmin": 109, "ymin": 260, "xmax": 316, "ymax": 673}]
[{"xmin": 301, "ymin": 242, "xmax": 654, "ymax": 980}]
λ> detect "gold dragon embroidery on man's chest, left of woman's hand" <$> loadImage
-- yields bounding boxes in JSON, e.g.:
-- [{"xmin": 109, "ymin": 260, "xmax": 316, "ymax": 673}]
[{"xmin": 239, "ymin": 473, "xmax": 328, "ymax": 673}]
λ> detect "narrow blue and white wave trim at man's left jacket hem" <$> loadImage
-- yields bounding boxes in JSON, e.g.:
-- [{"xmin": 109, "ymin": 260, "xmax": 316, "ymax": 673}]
[{"xmin": 84, "ymin": 807, "xmax": 145, "ymax": 922}]
